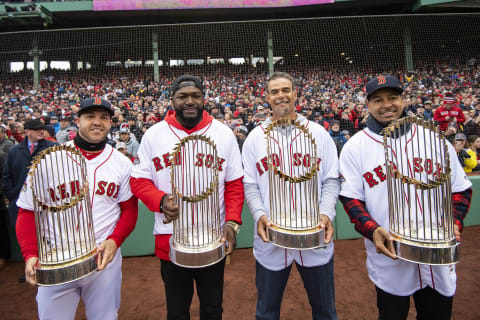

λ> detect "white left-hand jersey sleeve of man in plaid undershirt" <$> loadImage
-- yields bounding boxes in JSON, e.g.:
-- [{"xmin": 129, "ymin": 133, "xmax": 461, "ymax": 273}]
[{"xmin": 340, "ymin": 141, "xmax": 365, "ymax": 201}]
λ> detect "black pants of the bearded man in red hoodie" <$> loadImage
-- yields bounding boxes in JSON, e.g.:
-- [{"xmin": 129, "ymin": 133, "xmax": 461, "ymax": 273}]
[{"xmin": 160, "ymin": 259, "xmax": 225, "ymax": 320}]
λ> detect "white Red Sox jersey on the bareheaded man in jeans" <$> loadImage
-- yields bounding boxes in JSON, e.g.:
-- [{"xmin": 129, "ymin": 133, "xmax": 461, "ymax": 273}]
[{"xmin": 242, "ymin": 116, "xmax": 338, "ymax": 271}]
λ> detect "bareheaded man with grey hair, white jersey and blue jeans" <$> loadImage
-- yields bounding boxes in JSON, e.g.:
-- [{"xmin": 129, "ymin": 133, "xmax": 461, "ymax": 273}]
[{"xmin": 242, "ymin": 72, "xmax": 340, "ymax": 319}]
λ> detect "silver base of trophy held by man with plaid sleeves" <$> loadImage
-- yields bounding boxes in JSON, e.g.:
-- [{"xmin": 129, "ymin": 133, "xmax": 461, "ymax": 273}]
[{"xmin": 393, "ymin": 236, "xmax": 461, "ymax": 265}]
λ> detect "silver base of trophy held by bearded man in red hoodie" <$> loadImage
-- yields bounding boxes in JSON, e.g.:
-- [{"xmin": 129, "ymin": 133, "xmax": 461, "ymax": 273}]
[{"xmin": 169, "ymin": 236, "xmax": 225, "ymax": 268}]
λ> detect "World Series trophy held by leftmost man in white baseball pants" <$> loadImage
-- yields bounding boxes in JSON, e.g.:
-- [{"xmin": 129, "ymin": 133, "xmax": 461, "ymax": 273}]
[{"xmin": 28, "ymin": 145, "xmax": 97, "ymax": 286}]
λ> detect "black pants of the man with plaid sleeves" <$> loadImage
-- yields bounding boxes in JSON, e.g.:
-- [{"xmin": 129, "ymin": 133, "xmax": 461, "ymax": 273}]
[{"xmin": 375, "ymin": 286, "xmax": 453, "ymax": 320}]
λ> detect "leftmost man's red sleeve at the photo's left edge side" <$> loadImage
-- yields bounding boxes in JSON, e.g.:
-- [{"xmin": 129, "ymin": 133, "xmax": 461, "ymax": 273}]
[{"xmin": 15, "ymin": 208, "xmax": 38, "ymax": 261}]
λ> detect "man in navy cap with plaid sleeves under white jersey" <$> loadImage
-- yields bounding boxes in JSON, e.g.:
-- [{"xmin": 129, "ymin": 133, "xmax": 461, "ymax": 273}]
[{"xmin": 340, "ymin": 76, "xmax": 472, "ymax": 320}]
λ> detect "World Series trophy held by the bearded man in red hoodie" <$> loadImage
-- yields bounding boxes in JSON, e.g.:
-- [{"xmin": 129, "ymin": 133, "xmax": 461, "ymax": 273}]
[{"xmin": 170, "ymin": 135, "xmax": 225, "ymax": 268}]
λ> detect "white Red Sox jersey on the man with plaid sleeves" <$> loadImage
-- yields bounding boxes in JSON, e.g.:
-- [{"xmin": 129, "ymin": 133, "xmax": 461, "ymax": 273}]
[{"xmin": 340, "ymin": 125, "xmax": 471, "ymax": 296}]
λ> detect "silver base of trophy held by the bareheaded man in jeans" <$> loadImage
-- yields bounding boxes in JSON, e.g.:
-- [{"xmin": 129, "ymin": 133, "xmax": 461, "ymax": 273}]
[{"xmin": 268, "ymin": 225, "xmax": 326, "ymax": 250}]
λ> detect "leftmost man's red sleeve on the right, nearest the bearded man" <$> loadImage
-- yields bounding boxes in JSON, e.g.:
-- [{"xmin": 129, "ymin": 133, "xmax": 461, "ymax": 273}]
[{"xmin": 107, "ymin": 196, "xmax": 138, "ymax": 248}]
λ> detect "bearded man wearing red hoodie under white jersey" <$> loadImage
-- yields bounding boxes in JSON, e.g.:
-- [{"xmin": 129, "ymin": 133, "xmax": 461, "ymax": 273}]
[{"xmin": 131, "ymin": 75, "xmax": 244, "ymax": 319}]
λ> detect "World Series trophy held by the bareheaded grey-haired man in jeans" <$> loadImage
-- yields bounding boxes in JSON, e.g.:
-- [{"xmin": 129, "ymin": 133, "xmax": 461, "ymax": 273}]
[{"xmin": 265, "ymin": 119, "xmax": 325, "ymax": 250}]
